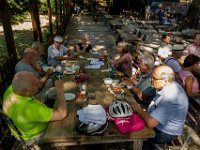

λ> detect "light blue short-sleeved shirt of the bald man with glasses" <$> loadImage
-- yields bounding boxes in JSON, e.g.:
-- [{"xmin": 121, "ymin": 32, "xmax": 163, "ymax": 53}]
[{"xmin": 147, "ymin": 82, "xmax": 188, "ymax": 135}]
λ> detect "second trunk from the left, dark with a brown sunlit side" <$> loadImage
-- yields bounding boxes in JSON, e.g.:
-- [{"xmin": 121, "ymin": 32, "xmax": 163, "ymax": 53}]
[{"xmin": 29, "ymin": 0, "xmax": 43, "ymax": 42}]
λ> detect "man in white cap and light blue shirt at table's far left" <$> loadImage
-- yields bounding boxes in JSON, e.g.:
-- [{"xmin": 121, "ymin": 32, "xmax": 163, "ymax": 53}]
[{"xmin": 47, "ymin": 35, "xmax": 69, "ymax": 66}]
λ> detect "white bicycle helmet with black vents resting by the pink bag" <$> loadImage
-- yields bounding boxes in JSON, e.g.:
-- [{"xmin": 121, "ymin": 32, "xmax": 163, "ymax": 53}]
[{"xmin": 109, "ymin": 100, "xmax": 133, "ymax": 118}]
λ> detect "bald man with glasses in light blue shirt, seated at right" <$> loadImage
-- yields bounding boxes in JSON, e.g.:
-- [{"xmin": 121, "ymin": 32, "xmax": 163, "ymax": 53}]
[{"xmin": 131, "ymin": 65, "xmax": 188, "ymax": 150}]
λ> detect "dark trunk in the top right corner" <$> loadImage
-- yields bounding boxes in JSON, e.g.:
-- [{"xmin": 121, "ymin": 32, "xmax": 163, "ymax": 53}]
[{"xmin": 183, "ymin": 0, "xmax": 200, "ymax": 27}]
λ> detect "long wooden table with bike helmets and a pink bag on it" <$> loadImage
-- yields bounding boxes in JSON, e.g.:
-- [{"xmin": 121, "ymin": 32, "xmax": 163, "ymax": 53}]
[{"xmin": 44, "ymin": 54, "xmax": 155, "ymax": 150}]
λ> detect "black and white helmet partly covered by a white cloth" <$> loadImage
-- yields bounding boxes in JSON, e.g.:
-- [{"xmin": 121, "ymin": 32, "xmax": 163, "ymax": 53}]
[{"xmin": 75, "ymin": 121, "xmax": 108, "ymax": 135}]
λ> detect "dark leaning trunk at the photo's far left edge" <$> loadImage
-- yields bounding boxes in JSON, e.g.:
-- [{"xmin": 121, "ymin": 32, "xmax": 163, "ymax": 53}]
[{"xmin": 0, "ymin": 0, "xmax": 17, "ymax": 65}]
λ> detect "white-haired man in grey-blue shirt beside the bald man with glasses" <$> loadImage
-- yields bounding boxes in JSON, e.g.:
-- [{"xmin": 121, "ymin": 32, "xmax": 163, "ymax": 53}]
[{"xmin": 122, "ymin": 53, "xmax": 156, "ymax": 108}]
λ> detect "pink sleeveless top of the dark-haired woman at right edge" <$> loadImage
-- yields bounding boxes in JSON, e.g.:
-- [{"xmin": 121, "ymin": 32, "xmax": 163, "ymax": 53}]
[{"xmin": 178, "ymin": 70, "xmax": 199, "ymax": 93}]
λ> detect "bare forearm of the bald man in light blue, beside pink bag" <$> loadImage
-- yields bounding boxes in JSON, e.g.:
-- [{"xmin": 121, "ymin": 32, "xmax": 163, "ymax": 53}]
[{"xmin": 131, "ymin": 103, "xmax": 159, "ymax": 128}]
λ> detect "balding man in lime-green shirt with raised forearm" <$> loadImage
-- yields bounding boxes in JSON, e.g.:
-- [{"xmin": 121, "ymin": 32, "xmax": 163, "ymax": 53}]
[{"xmin": 3, "ymin": 71, "xmax": 67, "ymax": 146}]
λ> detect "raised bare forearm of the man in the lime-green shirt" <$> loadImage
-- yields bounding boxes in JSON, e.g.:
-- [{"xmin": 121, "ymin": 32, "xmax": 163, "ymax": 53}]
[{"xmin": 51, "ymin": 80, "xmax": 67, "ymax": 121}]
